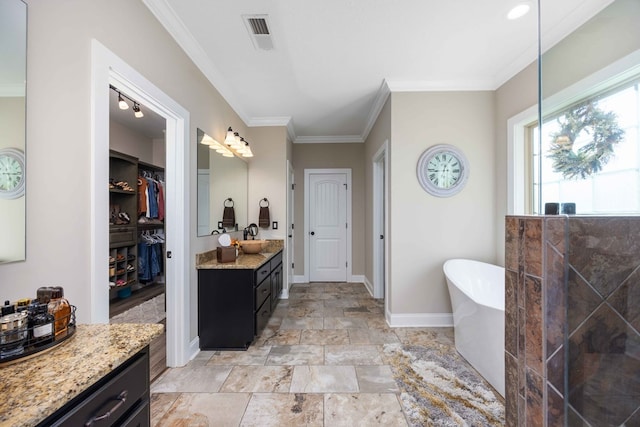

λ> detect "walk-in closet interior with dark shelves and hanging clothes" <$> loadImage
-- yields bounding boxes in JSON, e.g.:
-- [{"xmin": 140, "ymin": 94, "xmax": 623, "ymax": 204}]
[{"xmin": 108, "ymin": 86, "xmax": 170, "ymax": 380}]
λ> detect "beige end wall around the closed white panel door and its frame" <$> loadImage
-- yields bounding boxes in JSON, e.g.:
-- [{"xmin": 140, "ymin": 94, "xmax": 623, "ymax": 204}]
[{"xmin": 293, "ymin": 144, "xmax": 365, "ymax": 275}]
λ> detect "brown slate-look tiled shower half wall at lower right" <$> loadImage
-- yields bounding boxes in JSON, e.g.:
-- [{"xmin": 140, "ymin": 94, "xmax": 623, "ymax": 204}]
[{"xmin": 505, "ymin": 216, "xmax": 640, "ymax": 427}]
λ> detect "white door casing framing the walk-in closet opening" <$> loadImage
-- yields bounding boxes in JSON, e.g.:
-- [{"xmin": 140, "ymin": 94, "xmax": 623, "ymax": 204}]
[{"xmin": 90, "ymin": 40, "xmax": 191, "ymax": 367}]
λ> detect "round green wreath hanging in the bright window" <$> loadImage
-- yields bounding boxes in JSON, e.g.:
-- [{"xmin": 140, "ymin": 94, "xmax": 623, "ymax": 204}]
[{"xmin": 547, "ymin": 101, "xmax": 624, "ymax": 179}]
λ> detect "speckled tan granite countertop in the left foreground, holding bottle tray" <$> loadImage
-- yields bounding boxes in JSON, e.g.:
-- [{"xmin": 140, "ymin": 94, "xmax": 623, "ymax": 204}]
[{"xmin": 0, "ymin": 323, "xmax": 164, "ymax": 426}]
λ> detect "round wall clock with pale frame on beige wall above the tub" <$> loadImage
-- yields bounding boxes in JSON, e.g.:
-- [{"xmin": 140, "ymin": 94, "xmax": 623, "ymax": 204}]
[{"xmin": 417, "ymin": 144, "xmax": 469, "ymax": 197}]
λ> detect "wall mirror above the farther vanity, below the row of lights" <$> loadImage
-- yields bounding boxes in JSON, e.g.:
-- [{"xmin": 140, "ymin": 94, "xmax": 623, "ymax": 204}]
[{"xmin": 197, "ymin": 129, "xmax": 248, "ymax": 236}]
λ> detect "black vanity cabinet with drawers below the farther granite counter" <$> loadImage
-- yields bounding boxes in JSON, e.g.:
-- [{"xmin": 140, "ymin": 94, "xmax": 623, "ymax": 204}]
[{"xmin": 198, "ymin": 251, "xmax": 282, "ymax": 350}]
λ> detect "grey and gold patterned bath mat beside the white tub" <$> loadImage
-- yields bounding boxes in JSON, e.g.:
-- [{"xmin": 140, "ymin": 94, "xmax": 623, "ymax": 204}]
[{"xmin": 384, "ymin": 344, "xmax": 504, "ymax": 427}]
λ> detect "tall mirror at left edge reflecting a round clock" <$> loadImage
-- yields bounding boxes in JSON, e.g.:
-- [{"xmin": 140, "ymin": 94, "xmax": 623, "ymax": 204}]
[{"xmin": 0, "ymin": 0, "xmax": 27, "ymax": 263}]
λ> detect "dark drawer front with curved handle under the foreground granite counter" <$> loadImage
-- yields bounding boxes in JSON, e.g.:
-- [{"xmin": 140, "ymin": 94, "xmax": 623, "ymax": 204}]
[{"xmin": 54, "ymin": 357, "xmax": 149, "ymax": 427}]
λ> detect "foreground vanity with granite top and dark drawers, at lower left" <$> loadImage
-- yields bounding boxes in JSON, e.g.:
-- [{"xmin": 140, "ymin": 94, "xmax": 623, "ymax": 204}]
[{"xmin": 0, "ymin": 324, "xmax": 164, "ymax": 426}]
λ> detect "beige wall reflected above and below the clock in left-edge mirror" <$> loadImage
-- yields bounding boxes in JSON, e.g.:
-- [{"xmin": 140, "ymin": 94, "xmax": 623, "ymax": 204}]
[{"xmin": 0, "ymin": 96, "xmax": 27, "ymax": 262}]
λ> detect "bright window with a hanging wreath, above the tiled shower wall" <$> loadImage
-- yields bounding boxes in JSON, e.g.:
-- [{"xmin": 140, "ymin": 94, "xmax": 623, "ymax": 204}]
[{"xmin": 525, "ymin": 76, "xmax": 640, "ymax": 214}]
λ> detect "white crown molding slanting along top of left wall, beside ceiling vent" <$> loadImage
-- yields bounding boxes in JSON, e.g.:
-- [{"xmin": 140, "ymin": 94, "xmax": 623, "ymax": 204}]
[{"xmin": 142, "ymin": 0, "xmax": 250, "ymax": 124}]
